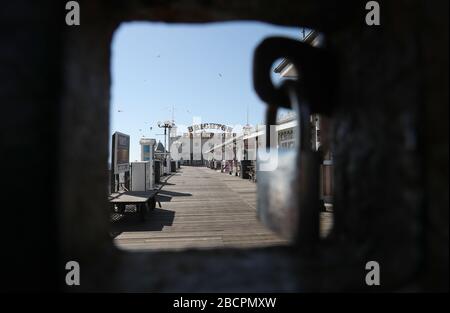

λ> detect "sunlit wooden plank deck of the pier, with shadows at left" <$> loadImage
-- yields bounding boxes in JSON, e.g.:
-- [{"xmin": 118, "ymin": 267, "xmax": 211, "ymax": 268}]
[{"xmin": 111, "ymin": 166, "xmax": 287, "ymax": 250}]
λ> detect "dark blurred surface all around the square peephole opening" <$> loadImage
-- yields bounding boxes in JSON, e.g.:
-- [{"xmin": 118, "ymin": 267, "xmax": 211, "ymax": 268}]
[{"xmin": 0, "ymin": 0, "xmax": 449, "ymax": 291}]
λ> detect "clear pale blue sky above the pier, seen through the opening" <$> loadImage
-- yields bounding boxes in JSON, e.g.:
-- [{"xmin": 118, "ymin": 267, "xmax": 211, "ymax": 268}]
[{"xmin": 110, "ymin": 22, "xmax": 300, "ymax": 161}]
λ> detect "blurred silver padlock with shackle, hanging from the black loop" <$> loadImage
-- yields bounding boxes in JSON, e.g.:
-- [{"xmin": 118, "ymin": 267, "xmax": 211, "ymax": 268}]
[{"xmin": 257, "ymin": 81, "xmax": 320, "ymax": 250}]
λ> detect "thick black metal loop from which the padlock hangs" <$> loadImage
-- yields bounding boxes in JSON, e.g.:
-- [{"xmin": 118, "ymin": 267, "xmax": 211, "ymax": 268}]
[{"xmin": 253, "ymin": 37, "xmax": 337, "ymax": 115}]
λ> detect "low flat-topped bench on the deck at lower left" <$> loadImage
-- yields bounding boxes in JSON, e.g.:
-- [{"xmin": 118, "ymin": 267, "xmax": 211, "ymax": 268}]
[{"xmin": 108, "ymin": 190, "xmax": 161, "ymax": 221}]
